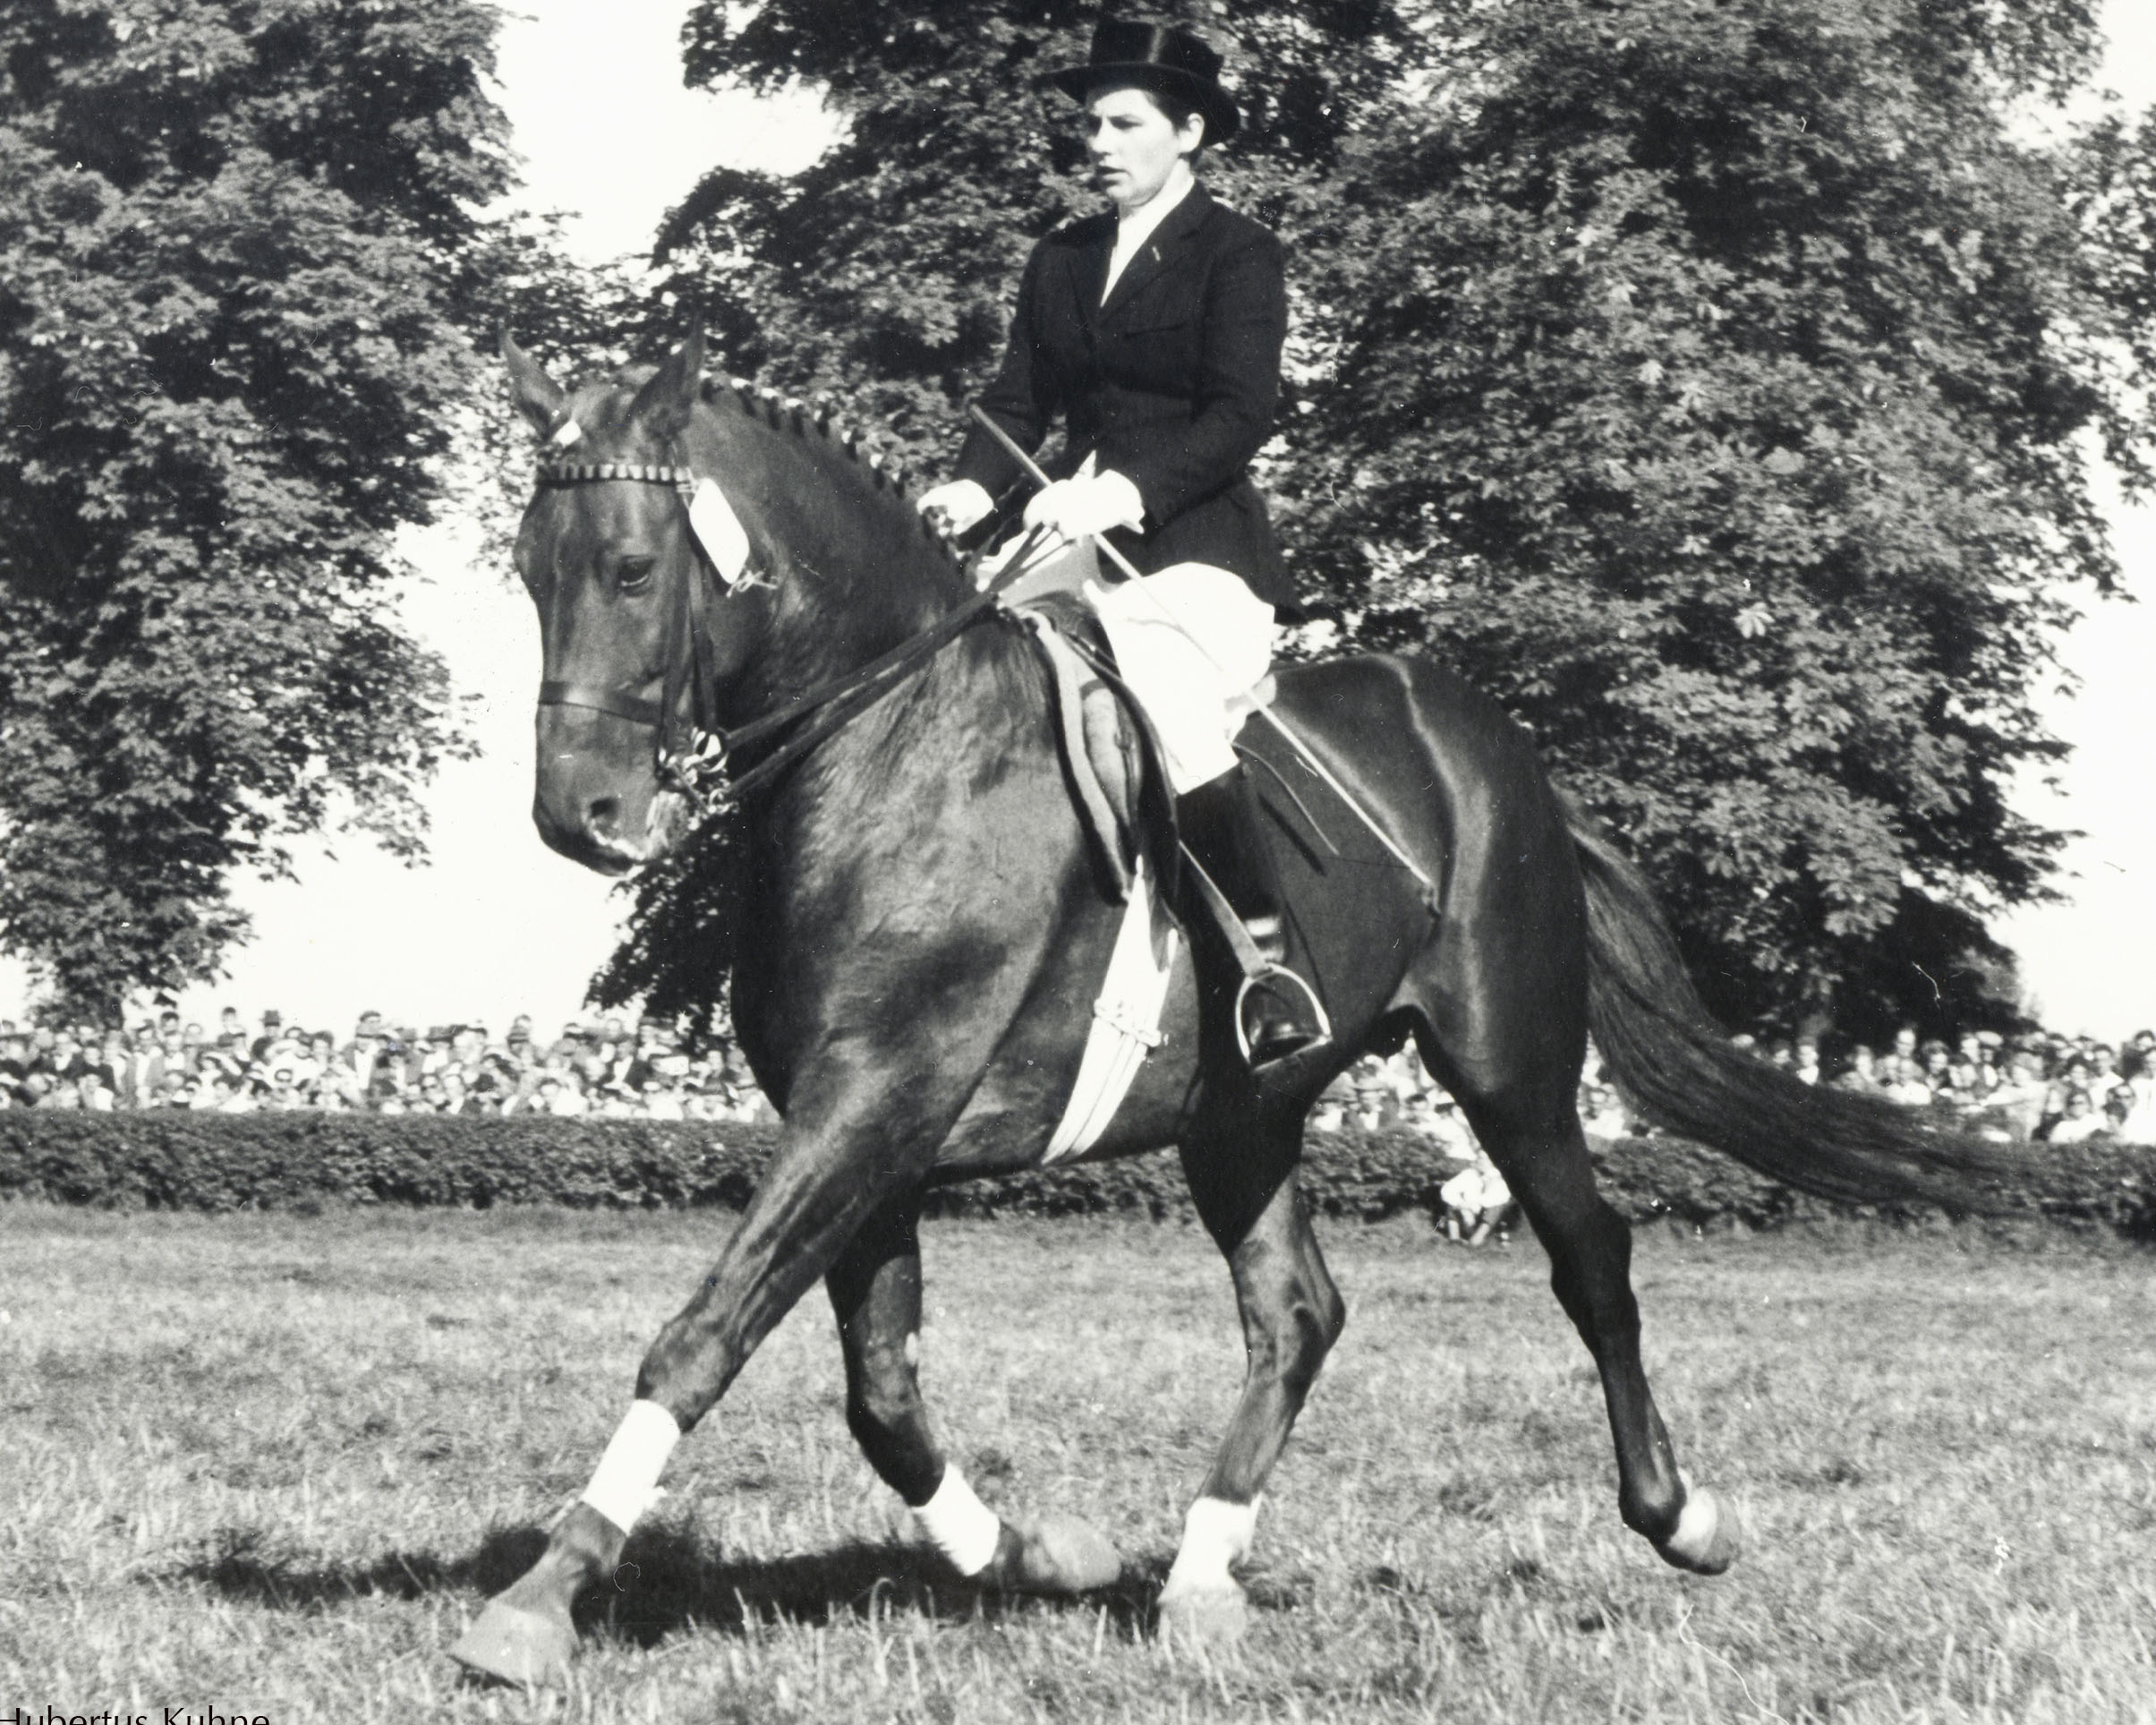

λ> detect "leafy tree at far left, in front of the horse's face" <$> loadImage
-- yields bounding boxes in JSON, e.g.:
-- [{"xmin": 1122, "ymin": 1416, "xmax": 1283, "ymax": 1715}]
[{"xmin": 0, "ymin": 0, "xmax": 509, "ymax": 1009}]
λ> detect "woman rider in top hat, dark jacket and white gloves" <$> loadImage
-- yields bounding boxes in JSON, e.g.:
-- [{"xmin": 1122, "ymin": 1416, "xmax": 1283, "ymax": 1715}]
[{"xmin": 921, "ymin": 20, "xmax": 1319, "ymax": 1067}]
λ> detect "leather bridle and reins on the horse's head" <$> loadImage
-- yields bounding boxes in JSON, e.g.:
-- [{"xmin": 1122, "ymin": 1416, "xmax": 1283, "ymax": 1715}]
[{"xmin": 539, "ymin": 461, "xmax": 1044, "ymax": 811}]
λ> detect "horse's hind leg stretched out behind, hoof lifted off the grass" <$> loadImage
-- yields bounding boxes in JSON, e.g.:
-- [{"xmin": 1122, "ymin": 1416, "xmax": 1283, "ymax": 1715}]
[{"xmin": 1423, "ymin": 1046, "xmax": 1742, "ymax": 1576}]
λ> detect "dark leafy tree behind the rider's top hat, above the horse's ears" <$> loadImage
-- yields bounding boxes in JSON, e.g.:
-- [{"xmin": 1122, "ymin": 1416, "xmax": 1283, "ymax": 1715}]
[{"xmin": 658, "ymin": 0, "xmax": 1417, "ymax": 464}]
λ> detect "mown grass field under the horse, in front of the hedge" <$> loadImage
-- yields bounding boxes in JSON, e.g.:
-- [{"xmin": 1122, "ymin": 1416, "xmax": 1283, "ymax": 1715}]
[{"xmin": 0, "ymin": 1205, "xmax": 2156, "ymax": 1725}]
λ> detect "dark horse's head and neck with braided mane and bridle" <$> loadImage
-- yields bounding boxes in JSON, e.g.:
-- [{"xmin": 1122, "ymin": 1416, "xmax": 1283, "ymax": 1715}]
[{"xmin": 502, "ymin": 332, "xmax": 964, "ymax": 874}]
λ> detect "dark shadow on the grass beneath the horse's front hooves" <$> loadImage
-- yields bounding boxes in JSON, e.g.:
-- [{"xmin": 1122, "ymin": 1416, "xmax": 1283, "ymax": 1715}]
[{"xmin": 164, "ymin": 1526, "xmax": 1166, "ymax": 1647}]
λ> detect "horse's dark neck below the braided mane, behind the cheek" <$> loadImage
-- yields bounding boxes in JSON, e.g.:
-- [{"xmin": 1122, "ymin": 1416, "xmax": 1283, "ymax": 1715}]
[{"xmin": 687, "ymin": 392, "xmax": 966, "ymax": 701}]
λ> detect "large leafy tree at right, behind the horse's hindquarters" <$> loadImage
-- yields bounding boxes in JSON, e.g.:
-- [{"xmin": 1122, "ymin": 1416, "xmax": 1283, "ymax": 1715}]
[{"xmin": 1291, "ymin": 0, "xmax": 2150, "ymax": 1030}]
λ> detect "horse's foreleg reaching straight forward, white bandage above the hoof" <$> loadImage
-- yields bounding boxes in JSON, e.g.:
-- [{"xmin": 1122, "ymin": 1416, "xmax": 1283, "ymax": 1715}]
[{"xmin": 450, "ymin": 1074, "xmax": 966, "ymax": 1684}]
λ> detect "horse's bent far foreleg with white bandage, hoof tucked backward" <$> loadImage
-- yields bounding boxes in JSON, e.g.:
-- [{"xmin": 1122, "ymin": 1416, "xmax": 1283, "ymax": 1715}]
[{"xmin": 823, "ymin": 1199, "xmax": 1123, "ymax": 1593}]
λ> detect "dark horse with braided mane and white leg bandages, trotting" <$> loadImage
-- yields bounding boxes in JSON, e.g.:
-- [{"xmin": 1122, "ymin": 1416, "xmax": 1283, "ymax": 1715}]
[{"xmin": 457, "ymin": 337, "xmax": 1983, "ymax": 1679}]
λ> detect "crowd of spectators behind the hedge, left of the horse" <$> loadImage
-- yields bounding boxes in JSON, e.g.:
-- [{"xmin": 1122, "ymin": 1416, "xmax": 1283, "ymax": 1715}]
[{"xmin": 0, "ymin": 1007, "xmax": 776, "ymax": 1122}]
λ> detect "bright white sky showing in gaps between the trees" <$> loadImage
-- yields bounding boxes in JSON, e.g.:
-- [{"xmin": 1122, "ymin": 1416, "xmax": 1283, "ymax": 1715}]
[{"xmin": 0, "ymin": 0, "xmax": 2156, "ymax": 1035}]
